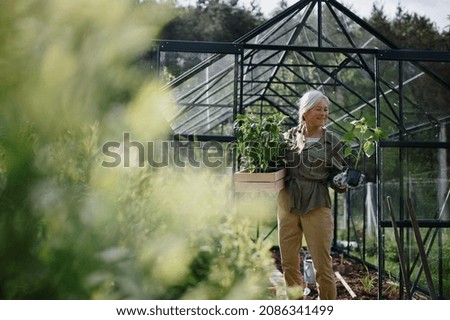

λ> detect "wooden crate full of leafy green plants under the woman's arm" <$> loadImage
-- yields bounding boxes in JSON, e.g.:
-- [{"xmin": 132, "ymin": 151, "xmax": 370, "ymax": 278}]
[{"xmin": 234, "ymin": 113, "xmax": 286, "ymax": 192}]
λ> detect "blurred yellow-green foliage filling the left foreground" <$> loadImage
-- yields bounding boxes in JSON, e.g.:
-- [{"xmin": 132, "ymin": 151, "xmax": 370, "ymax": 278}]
[{"xmin": 0, "ymin": 0, "xmax": 272, "ymax": 299}]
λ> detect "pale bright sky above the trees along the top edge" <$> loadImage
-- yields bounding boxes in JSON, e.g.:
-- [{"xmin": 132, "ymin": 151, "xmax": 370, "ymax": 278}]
[{"xmin": 179, "ymin": 0, "xmax": 450, "ymax": 31}]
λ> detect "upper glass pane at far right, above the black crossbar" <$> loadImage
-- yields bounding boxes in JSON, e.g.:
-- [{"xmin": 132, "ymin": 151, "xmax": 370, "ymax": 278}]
[{"xmin": 380, "ymin": 61, "xmax": 450, "ymax": 142}]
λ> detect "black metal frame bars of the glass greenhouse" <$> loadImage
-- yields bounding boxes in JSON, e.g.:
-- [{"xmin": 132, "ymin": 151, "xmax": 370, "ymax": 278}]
[{"xmin": 154, "ymin": 0, "xmax": 450, "ymax": 299}]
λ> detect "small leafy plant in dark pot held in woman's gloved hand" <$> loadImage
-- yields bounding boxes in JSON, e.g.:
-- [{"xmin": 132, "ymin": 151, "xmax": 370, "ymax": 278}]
[{"xmin": 342, "ymin": 117, "xmax": 386, "ymax": 186}]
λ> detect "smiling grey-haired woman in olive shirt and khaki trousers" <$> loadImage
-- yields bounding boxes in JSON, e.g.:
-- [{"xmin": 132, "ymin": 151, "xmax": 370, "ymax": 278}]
[{"xmin": 278, "ymin": 90, "xmax": 346, "ymax": 300}]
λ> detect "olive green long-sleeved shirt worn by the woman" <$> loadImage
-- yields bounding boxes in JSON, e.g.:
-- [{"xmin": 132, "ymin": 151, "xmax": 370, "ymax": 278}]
[{"xmin": 285, "ymin": 127, "xmax": 345, "ymax": 215}]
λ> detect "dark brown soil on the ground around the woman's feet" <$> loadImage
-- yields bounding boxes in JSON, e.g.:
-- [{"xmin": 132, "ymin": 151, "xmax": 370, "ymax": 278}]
[{"xmin": 271, "ymin": 246, "xmax": 427, "ymax": 300}]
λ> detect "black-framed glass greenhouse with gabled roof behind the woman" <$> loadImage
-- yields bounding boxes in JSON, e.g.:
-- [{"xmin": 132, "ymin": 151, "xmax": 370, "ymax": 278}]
[{"xmin": 152, "ymin": 0, "xmax": 450, "ymax": 299}]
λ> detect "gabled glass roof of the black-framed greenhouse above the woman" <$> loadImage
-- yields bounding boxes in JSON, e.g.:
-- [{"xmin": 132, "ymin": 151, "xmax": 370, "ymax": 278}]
[{"xmin": 157, "ymin": 0, "xmax": 450, "ymax": 141}]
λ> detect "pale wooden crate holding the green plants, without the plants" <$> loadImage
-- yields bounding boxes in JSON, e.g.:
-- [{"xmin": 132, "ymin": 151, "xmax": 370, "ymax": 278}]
[{"xmin": 233, "ymin": 169, "xmax": 286, "ymax": 192}]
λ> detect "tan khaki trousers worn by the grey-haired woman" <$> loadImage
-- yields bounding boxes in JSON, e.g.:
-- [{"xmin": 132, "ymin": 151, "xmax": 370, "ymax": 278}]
[{"xmin": 278, "ymin": 189, "xmax": 336, "ymax": 300}]
